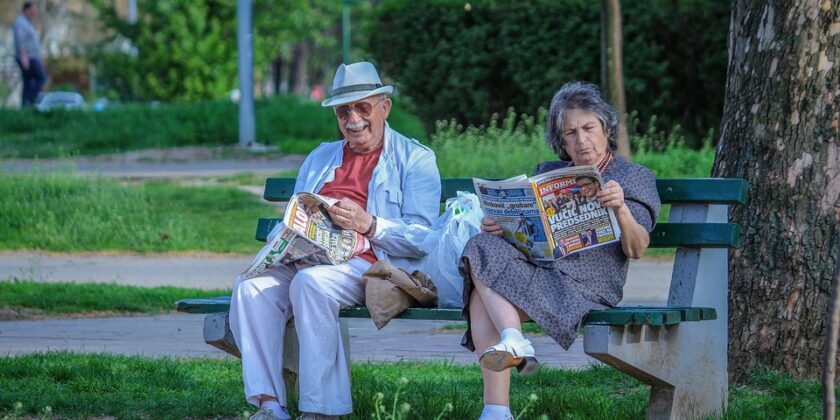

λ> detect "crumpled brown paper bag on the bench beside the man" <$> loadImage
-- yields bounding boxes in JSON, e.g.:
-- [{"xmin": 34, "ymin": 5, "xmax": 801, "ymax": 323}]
[{"xmin": 362, "ymin": 261, "xmax": 437, "ymax": 329}]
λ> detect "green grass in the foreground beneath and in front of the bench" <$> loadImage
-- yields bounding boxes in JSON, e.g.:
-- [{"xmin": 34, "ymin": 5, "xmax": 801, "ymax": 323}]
[{"xmin": 0, "ymin": 352, "xmax": 821, "ymax": 420}]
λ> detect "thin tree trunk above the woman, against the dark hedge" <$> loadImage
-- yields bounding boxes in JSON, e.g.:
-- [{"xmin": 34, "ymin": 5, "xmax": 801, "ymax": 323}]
[{"xmin": 601, "ymin": 0, "xmax": 631, "ymax": 160}]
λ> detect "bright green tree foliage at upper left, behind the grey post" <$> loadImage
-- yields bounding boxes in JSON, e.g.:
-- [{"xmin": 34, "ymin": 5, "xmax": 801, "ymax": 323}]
[{"xmin": 94, "ymin": 0, "xmax": 340, "ymax": 100}]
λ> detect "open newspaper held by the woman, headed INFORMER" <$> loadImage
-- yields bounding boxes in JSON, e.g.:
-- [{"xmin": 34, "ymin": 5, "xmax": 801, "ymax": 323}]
[{"xmin": 473, "ymin": 165, "xmax": 621, "ymax": 261}]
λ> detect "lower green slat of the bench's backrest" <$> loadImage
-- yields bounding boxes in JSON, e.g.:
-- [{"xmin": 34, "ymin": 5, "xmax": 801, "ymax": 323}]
[{"xmin": 255, "ymin": 218, "xmax": 740, "ymax": 248}]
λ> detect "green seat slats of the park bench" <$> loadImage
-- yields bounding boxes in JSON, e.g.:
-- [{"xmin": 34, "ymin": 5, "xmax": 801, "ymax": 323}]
[{"xmin": 175, "ymin": 296, "xmax": 717, "ymax": 326}]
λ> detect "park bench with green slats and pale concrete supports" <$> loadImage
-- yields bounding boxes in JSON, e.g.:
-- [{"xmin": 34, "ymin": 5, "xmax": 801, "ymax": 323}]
[{"xmin": 177, "ymin": 178, "xmax": 746, "ymax": 419}]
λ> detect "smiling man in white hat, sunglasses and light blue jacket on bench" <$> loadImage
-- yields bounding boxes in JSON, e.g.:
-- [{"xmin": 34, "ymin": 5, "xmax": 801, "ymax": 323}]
[{"xmin": 230, "ymin": 62, "xmax": 440, "ymax": 419}]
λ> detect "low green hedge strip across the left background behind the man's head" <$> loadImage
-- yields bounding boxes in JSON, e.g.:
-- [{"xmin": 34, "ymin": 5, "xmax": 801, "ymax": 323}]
[{"xmin": 0, "ymin": 96, "xmax": 426, "ymax": 158}]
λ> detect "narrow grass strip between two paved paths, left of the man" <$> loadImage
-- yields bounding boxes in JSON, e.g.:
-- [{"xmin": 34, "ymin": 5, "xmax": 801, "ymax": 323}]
[{"xmin": 0, "ymin": 280, "xmax": 230, "ymax": 316}]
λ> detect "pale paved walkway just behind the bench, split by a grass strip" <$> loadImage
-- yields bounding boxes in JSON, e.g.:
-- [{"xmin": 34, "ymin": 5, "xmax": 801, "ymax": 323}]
[{"xmin": 0, "ymin": 252, "xmax": 672, "ymax": 368}]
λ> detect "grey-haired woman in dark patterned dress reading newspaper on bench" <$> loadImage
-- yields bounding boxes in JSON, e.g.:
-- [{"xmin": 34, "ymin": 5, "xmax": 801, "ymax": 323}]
[{"xmin": 461, "ymin": 82, "xmax": 660, "ymax": 419}]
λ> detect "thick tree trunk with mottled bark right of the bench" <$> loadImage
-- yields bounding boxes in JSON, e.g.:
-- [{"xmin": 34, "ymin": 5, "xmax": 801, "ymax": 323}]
[{"xmin": 713, "ymin": 0, "xmax": 840, "ymax": 379}]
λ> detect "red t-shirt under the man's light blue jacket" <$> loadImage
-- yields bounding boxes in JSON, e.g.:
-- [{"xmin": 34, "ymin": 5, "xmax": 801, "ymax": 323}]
[{"xmin": 318, "ymin": 143, "xmax": 382, "ymax": 264}]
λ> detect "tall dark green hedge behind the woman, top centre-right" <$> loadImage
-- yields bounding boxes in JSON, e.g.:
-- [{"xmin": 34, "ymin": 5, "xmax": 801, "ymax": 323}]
[{"xmin": 369, "ymin": 0, "xmax": 729, "ymax": 146}]
